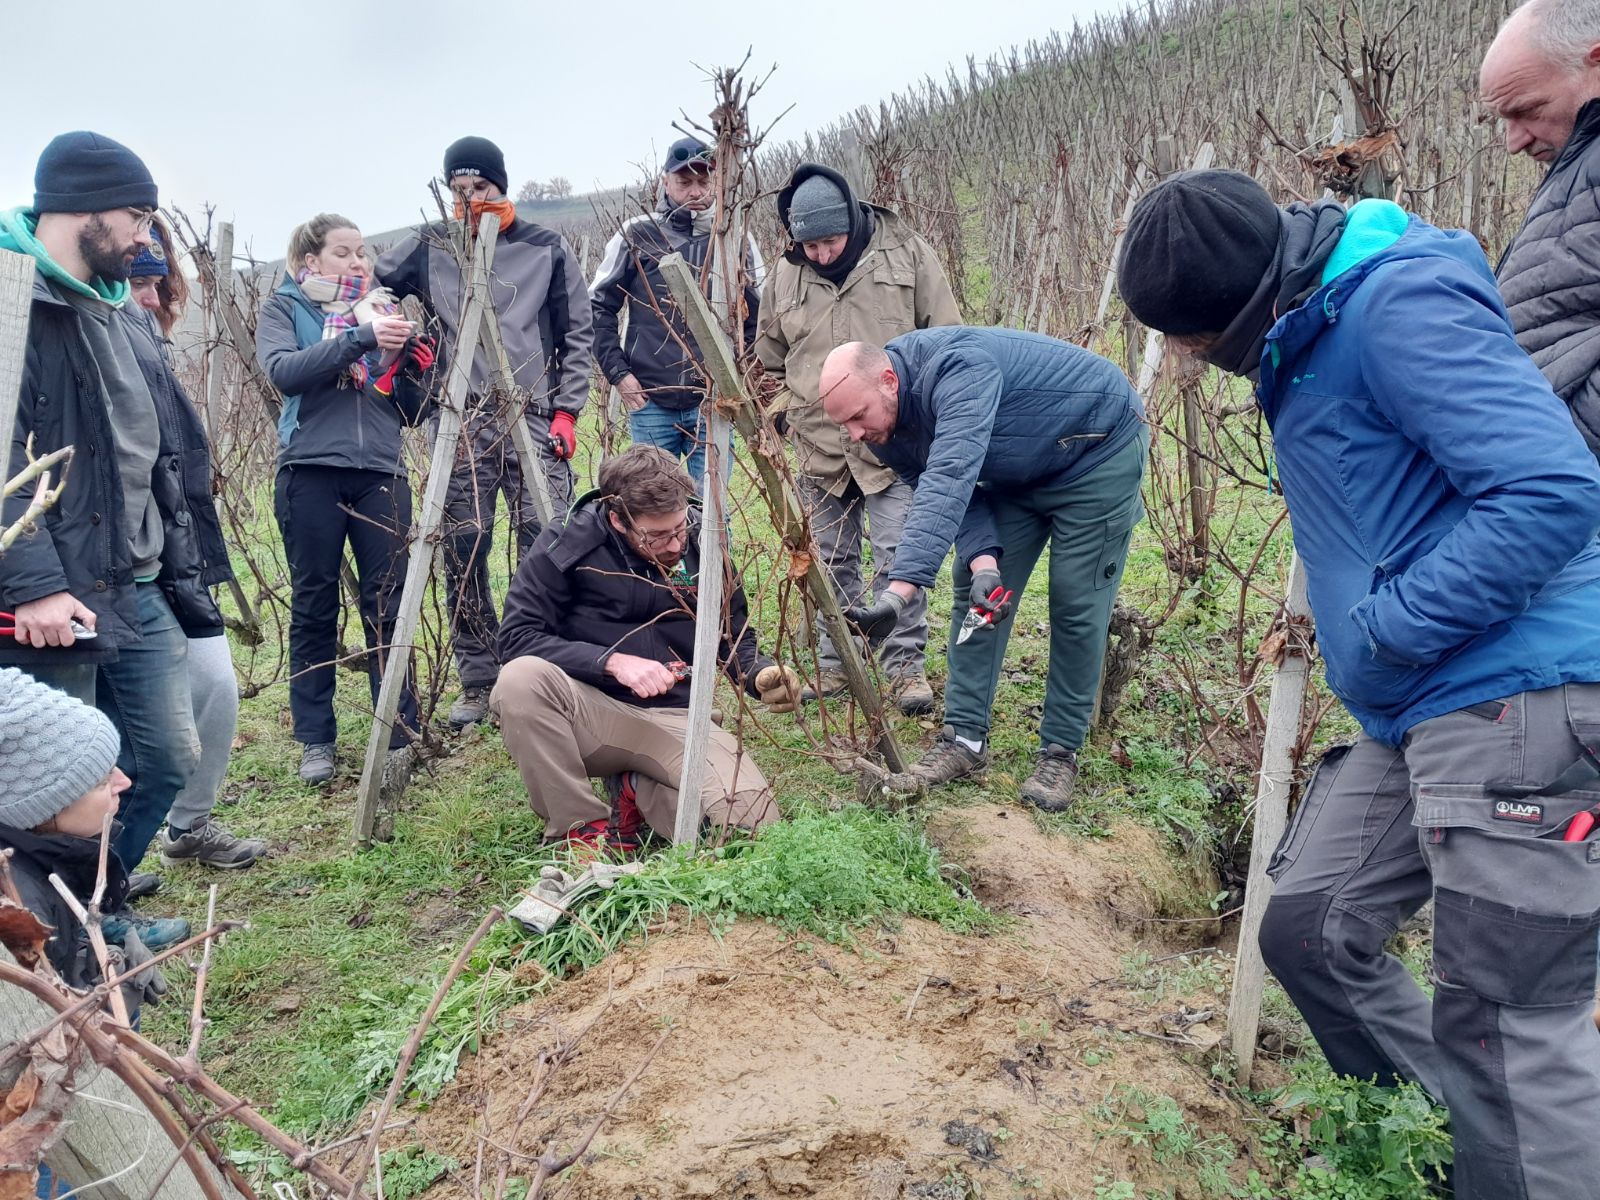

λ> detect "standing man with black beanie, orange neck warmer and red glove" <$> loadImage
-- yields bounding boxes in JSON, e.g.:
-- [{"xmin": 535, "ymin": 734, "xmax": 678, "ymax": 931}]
[{"xmin": 376, "ymin": 138, "xmax": 594, "ymax": 728}]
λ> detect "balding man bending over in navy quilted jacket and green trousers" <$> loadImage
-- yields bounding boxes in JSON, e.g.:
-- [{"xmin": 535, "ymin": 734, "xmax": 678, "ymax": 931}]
[{"xmin": 819, "ymin": 326, "xmax": 1149, "ymax": 813}]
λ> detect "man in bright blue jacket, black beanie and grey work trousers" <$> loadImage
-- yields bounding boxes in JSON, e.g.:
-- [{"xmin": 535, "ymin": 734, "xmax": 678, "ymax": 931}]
[{"xmin": 1120, "ymin": 171, "xmax": 1600, "ymax": 1200}]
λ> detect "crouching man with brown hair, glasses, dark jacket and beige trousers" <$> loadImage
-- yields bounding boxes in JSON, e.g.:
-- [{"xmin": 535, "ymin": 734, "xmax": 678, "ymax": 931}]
[{"xmin": 490, "ymin": 446, "xmax": 800, "ymax": 851}]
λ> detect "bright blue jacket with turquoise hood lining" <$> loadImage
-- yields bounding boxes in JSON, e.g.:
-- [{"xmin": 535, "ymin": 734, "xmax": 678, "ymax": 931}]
[{"xmin": 1258, "ymin": 200, "xmax": 1600, "ymax": 746}]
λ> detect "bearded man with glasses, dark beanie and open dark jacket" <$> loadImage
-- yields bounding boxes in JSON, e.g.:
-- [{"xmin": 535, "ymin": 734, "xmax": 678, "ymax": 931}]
[{"xmin": 0, "ymin": 131, "xmax": 198, "ymax": 942}]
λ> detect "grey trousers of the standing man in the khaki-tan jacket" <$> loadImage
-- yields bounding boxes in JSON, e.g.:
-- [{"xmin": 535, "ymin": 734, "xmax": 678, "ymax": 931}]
[{"xmin": 795, "ymin": 475, "xmax": 928, "ymax": 678}]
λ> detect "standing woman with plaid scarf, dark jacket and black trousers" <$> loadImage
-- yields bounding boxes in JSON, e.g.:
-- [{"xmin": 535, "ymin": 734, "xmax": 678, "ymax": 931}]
[{"xmin": 256, "ymin": 213, "xmax": 432, "ymax": 784}]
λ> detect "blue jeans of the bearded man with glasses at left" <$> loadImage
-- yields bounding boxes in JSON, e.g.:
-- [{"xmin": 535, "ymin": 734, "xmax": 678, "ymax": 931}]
[{"xmin": 32, "ymin": 582, "xmax": 200, "ymax": 870}]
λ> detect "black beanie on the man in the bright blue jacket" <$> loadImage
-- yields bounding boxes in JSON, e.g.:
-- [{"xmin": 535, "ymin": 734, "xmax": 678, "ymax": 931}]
[{"xmin": 1117, "ymin": 171, "xmax": 1283, "ymax": 338}]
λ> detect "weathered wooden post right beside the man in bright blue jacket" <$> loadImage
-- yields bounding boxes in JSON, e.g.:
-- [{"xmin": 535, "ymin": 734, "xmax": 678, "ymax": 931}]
[{"xmin": 1227, "ymin": 555, "xmax": 1312, "ymax": 1086}]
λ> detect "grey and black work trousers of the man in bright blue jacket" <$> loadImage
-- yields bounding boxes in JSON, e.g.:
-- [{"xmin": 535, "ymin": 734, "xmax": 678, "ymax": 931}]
[{"xmin": 1261, "ymin": 683, "xmax": 1600, "ymax": 1200}]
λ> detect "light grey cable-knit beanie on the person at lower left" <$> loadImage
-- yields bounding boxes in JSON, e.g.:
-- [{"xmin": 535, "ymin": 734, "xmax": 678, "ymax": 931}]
[{"xmin": 0, "ymin": 667, "xmax": 122, "ymax": 829}]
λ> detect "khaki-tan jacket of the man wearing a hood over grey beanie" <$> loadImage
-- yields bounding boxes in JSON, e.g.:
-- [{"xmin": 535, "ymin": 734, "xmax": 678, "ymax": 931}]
[{"xmin": 755, "ymin": 205, "xmax": 962, "ymax": 496}]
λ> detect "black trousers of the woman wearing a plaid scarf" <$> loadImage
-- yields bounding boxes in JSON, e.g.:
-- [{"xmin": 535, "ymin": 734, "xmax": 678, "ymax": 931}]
[{"xmin": 274, "ymin": 466, "xmax": 418, "ymax": 747}]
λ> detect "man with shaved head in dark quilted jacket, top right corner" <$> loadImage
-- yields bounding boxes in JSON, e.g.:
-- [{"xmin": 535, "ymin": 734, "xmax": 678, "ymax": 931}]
[{"xmin": 1478, "ymin": 0, "xmax": 1600, "ymax": 454}]
